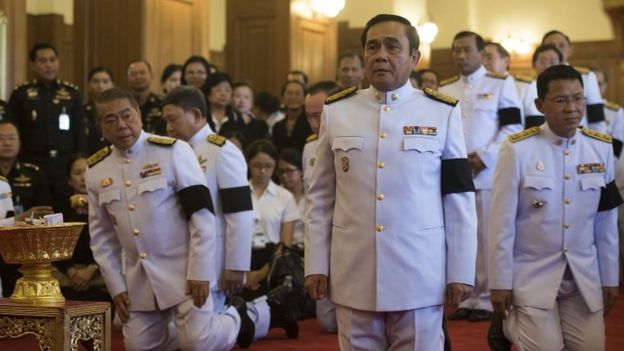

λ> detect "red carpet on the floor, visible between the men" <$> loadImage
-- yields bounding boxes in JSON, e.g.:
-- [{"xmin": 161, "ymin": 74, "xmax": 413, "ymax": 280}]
[{"xmin": 0, "ymin": 291, "xmax": 624, "ymax": 351}]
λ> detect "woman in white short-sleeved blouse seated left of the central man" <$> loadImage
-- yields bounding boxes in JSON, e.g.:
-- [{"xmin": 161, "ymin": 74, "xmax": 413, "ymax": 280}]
[{"xmin": 247, "ymin": 140, "xmax": 300, "ymax": 290}]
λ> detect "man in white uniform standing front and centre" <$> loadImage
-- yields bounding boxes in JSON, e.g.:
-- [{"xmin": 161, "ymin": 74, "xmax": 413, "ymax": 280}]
[{"xmin": 305, "ymin": 15, "xmax": 476, "ymax": 350}]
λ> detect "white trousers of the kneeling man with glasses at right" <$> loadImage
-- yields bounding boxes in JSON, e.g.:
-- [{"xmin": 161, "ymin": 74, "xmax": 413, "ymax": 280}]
[{"xmin": 503, "ymin": 280, "xmax": 605, "ymax": 351}]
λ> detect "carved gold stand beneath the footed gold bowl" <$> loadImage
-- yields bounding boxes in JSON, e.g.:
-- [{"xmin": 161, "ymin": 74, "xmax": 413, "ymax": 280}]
[{"xmin": 0, "ymin": 299, "xmax": 111, "ymax": 351}]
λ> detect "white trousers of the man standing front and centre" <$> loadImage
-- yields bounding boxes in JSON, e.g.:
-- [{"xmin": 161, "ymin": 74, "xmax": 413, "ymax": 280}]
[{"xmin": 336, "ymin": 304, "xmax": 444, "ymax": 351}]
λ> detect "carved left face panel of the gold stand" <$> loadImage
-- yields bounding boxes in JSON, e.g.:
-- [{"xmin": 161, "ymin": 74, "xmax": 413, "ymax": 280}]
[{"xmin": 0, "ymin": 316, "xmax": 54, "ymax": 351}]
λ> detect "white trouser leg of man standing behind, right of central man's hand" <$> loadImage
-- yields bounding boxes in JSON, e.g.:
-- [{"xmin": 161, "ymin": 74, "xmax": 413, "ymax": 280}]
[{"xmin": 459, "ymin": 189, "xmax": 493, "ymax": 312}]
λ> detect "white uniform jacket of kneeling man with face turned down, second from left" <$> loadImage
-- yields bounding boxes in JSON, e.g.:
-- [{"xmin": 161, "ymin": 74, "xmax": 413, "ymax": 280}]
[{"xmin": 189, "ymin": 124, "xmax": 253, "ymax": 290}]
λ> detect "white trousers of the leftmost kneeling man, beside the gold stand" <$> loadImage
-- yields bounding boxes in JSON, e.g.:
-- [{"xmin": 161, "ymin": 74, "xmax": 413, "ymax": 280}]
[{"xmin": 123, "ymin": 298, "xmax": 240, "ymax": 351}]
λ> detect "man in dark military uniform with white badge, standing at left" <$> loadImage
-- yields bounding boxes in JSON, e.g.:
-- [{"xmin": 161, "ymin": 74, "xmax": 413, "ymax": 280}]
[{"xmin": 8, "ymin": 43, "xmax": 86, "ymax": 206}]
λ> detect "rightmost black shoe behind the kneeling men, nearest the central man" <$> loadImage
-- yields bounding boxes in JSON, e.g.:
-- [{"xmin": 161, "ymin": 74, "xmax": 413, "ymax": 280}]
[{"xmin": 267, "ymin": 277, "xmax": 299, "ymax": 339}]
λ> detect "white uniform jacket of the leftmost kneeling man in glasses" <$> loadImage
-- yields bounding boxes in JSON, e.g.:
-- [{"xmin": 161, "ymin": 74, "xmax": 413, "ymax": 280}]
[{"xmin": 87, "ymin": 132, "xmax": 216, "ymax": 311}]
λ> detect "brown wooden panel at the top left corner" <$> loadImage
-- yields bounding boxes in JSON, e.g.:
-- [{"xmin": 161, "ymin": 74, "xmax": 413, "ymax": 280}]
[{"xmin": 0, "ymin": 0, "xmax": 28, "ymax": 99}]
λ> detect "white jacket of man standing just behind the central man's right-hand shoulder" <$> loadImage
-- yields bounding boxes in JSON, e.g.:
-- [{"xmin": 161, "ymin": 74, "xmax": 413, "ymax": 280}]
[{"xmin": 440, "ymin": 66, "xmax": 522, "ymax": 190}]
